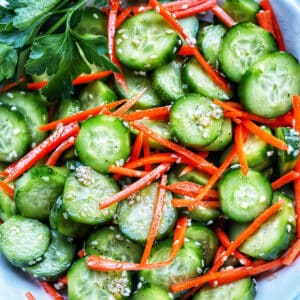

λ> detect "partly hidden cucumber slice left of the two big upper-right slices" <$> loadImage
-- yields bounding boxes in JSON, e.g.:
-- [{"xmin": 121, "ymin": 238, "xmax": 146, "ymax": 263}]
[{"xmin": 197, "ymin": 24, "xmax": 226, "ymax": 69}]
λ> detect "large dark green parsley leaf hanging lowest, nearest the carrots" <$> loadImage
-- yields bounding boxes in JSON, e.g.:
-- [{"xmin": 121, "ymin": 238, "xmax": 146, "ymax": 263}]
[{"xmin": 25, "ymin": 31, "xmax": 90, "ymax": 101}]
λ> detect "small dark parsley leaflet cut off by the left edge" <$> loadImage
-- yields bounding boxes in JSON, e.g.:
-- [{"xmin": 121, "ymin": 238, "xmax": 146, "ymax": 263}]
[{"xmin": 0, "ymin": 44, "xmax": 18, "ymax": 81}]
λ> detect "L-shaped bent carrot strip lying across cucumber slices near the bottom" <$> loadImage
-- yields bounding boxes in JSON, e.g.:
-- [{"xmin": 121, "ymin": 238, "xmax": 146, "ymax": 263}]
[{"xmin": 86, "ymin": 217, "xmax": 187, "ymax": 272}]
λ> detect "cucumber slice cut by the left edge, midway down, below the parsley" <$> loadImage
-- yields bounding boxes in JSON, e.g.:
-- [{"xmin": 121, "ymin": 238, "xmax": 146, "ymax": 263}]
[{"xmin": 0, "ymin": 105, "xmax": 31, "ymax": 163}]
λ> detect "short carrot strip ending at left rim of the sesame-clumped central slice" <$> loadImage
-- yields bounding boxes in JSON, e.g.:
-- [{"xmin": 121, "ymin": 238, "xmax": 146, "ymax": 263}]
[{"xmin": 122, "ymin": 106, "xmax": 171, "ymax": 122}]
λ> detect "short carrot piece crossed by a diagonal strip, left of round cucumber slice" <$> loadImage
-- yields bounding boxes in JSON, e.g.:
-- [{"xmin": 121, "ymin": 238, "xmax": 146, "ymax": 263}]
[{"xmin": 166, "ymin": 181, "xmax": 219, "ymax": 199}]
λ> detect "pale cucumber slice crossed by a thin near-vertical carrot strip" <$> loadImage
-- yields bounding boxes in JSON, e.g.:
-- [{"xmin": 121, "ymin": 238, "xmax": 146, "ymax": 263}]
[{"xmin": 117, "ymin": 183, "xmax": 177, "ymax": 243}]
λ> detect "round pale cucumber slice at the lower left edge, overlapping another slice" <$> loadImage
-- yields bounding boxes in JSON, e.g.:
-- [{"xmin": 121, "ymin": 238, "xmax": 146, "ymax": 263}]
[{"xmin": 0, "ymin": 216, "xmax": 50, "ymax": 267}]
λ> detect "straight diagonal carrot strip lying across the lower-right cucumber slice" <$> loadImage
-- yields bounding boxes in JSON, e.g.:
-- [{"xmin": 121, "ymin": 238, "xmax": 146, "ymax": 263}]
[{"xmin": 213, "ymin": 200, "xmax": 283, "ymax": 268}]
